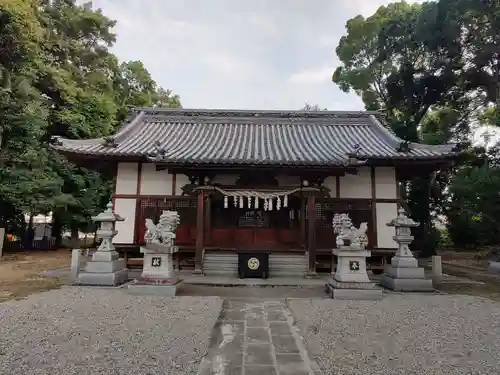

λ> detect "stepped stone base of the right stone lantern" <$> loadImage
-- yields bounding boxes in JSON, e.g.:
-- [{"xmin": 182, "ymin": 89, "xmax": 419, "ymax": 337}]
[{"xmin": 380, "ymin": 256, "xmax": 434, "ymax": 292}]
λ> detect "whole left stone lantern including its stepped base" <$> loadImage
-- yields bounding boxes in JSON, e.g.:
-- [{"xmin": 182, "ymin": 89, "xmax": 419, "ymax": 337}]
[{"xmin": 76, "ymin": 202, "xmax": 128, "ymax": 285}]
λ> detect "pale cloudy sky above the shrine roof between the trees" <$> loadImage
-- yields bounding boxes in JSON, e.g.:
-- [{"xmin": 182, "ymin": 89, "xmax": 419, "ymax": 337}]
[{"xmin": 83, "ymin": 0, "xmax": 426, "ymax": 110}]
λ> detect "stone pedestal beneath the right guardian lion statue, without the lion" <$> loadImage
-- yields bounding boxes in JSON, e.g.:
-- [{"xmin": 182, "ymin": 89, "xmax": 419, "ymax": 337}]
[{"xmin": 325, "ymin": 247, "xmax": 383, "ymax": 300}]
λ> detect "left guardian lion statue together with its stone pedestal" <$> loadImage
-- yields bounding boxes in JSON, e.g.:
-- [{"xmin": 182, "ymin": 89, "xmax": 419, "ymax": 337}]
[{"xmin": 128, "ymin": 211, "xmax": 182, "ymax": 296}]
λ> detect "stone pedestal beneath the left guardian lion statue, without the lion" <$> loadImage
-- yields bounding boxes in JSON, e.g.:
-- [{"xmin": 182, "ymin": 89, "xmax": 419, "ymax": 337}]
[{"xmin": 128, "ymin": 244, "xmax": 182, "ymax": 297}]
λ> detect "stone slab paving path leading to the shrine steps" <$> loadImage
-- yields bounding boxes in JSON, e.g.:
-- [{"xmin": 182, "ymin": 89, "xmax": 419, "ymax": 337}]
[{"xmin": 198, "ymin": 299, "xmax": 321, "ymax": 375}]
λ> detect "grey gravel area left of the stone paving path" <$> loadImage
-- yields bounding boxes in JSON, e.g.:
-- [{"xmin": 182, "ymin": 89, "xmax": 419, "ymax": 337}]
[{"xmin": 0, "ymin": 287, "xmax": 222, "ymax": 375}]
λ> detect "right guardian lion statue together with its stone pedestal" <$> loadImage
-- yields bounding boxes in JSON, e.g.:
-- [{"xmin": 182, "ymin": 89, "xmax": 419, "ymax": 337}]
[{"xmin": 325, "ymin": 214, "xmax": 382, "ymax": 300}]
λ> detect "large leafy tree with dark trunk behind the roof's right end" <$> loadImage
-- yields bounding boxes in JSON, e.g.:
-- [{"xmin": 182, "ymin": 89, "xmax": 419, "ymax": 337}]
[{"xmin": 333, "ymin": 2, "xmax": 469, "ymax": 251}]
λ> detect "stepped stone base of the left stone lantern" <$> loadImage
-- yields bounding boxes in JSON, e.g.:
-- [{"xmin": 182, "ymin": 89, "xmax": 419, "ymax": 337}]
[{"xmin": 75, "ymin": 250, "xmax": 128, "ymax": 286}]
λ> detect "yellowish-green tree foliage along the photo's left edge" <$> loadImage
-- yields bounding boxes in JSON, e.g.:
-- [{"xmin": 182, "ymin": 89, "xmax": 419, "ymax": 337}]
[{"xmin": 0, "ymin": 0, "xmax": 62, "ymax": 241}]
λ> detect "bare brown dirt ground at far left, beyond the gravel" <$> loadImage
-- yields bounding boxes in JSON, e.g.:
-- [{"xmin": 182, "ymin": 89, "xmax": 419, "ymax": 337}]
[{"xmin": 0, "ymin": 249, "xmax": 71, "ymax": 302}]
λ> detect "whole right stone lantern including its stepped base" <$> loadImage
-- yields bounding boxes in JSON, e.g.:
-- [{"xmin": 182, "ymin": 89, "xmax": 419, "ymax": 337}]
[{"xmin": 380, "ymin": 208, "xmax": 434, "ymax": 292}]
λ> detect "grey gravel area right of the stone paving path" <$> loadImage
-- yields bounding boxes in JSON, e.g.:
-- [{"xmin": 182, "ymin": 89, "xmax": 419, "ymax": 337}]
[{"xmin": 288, "ymin": 295, "xmax": 500, "ymax": 375}]
